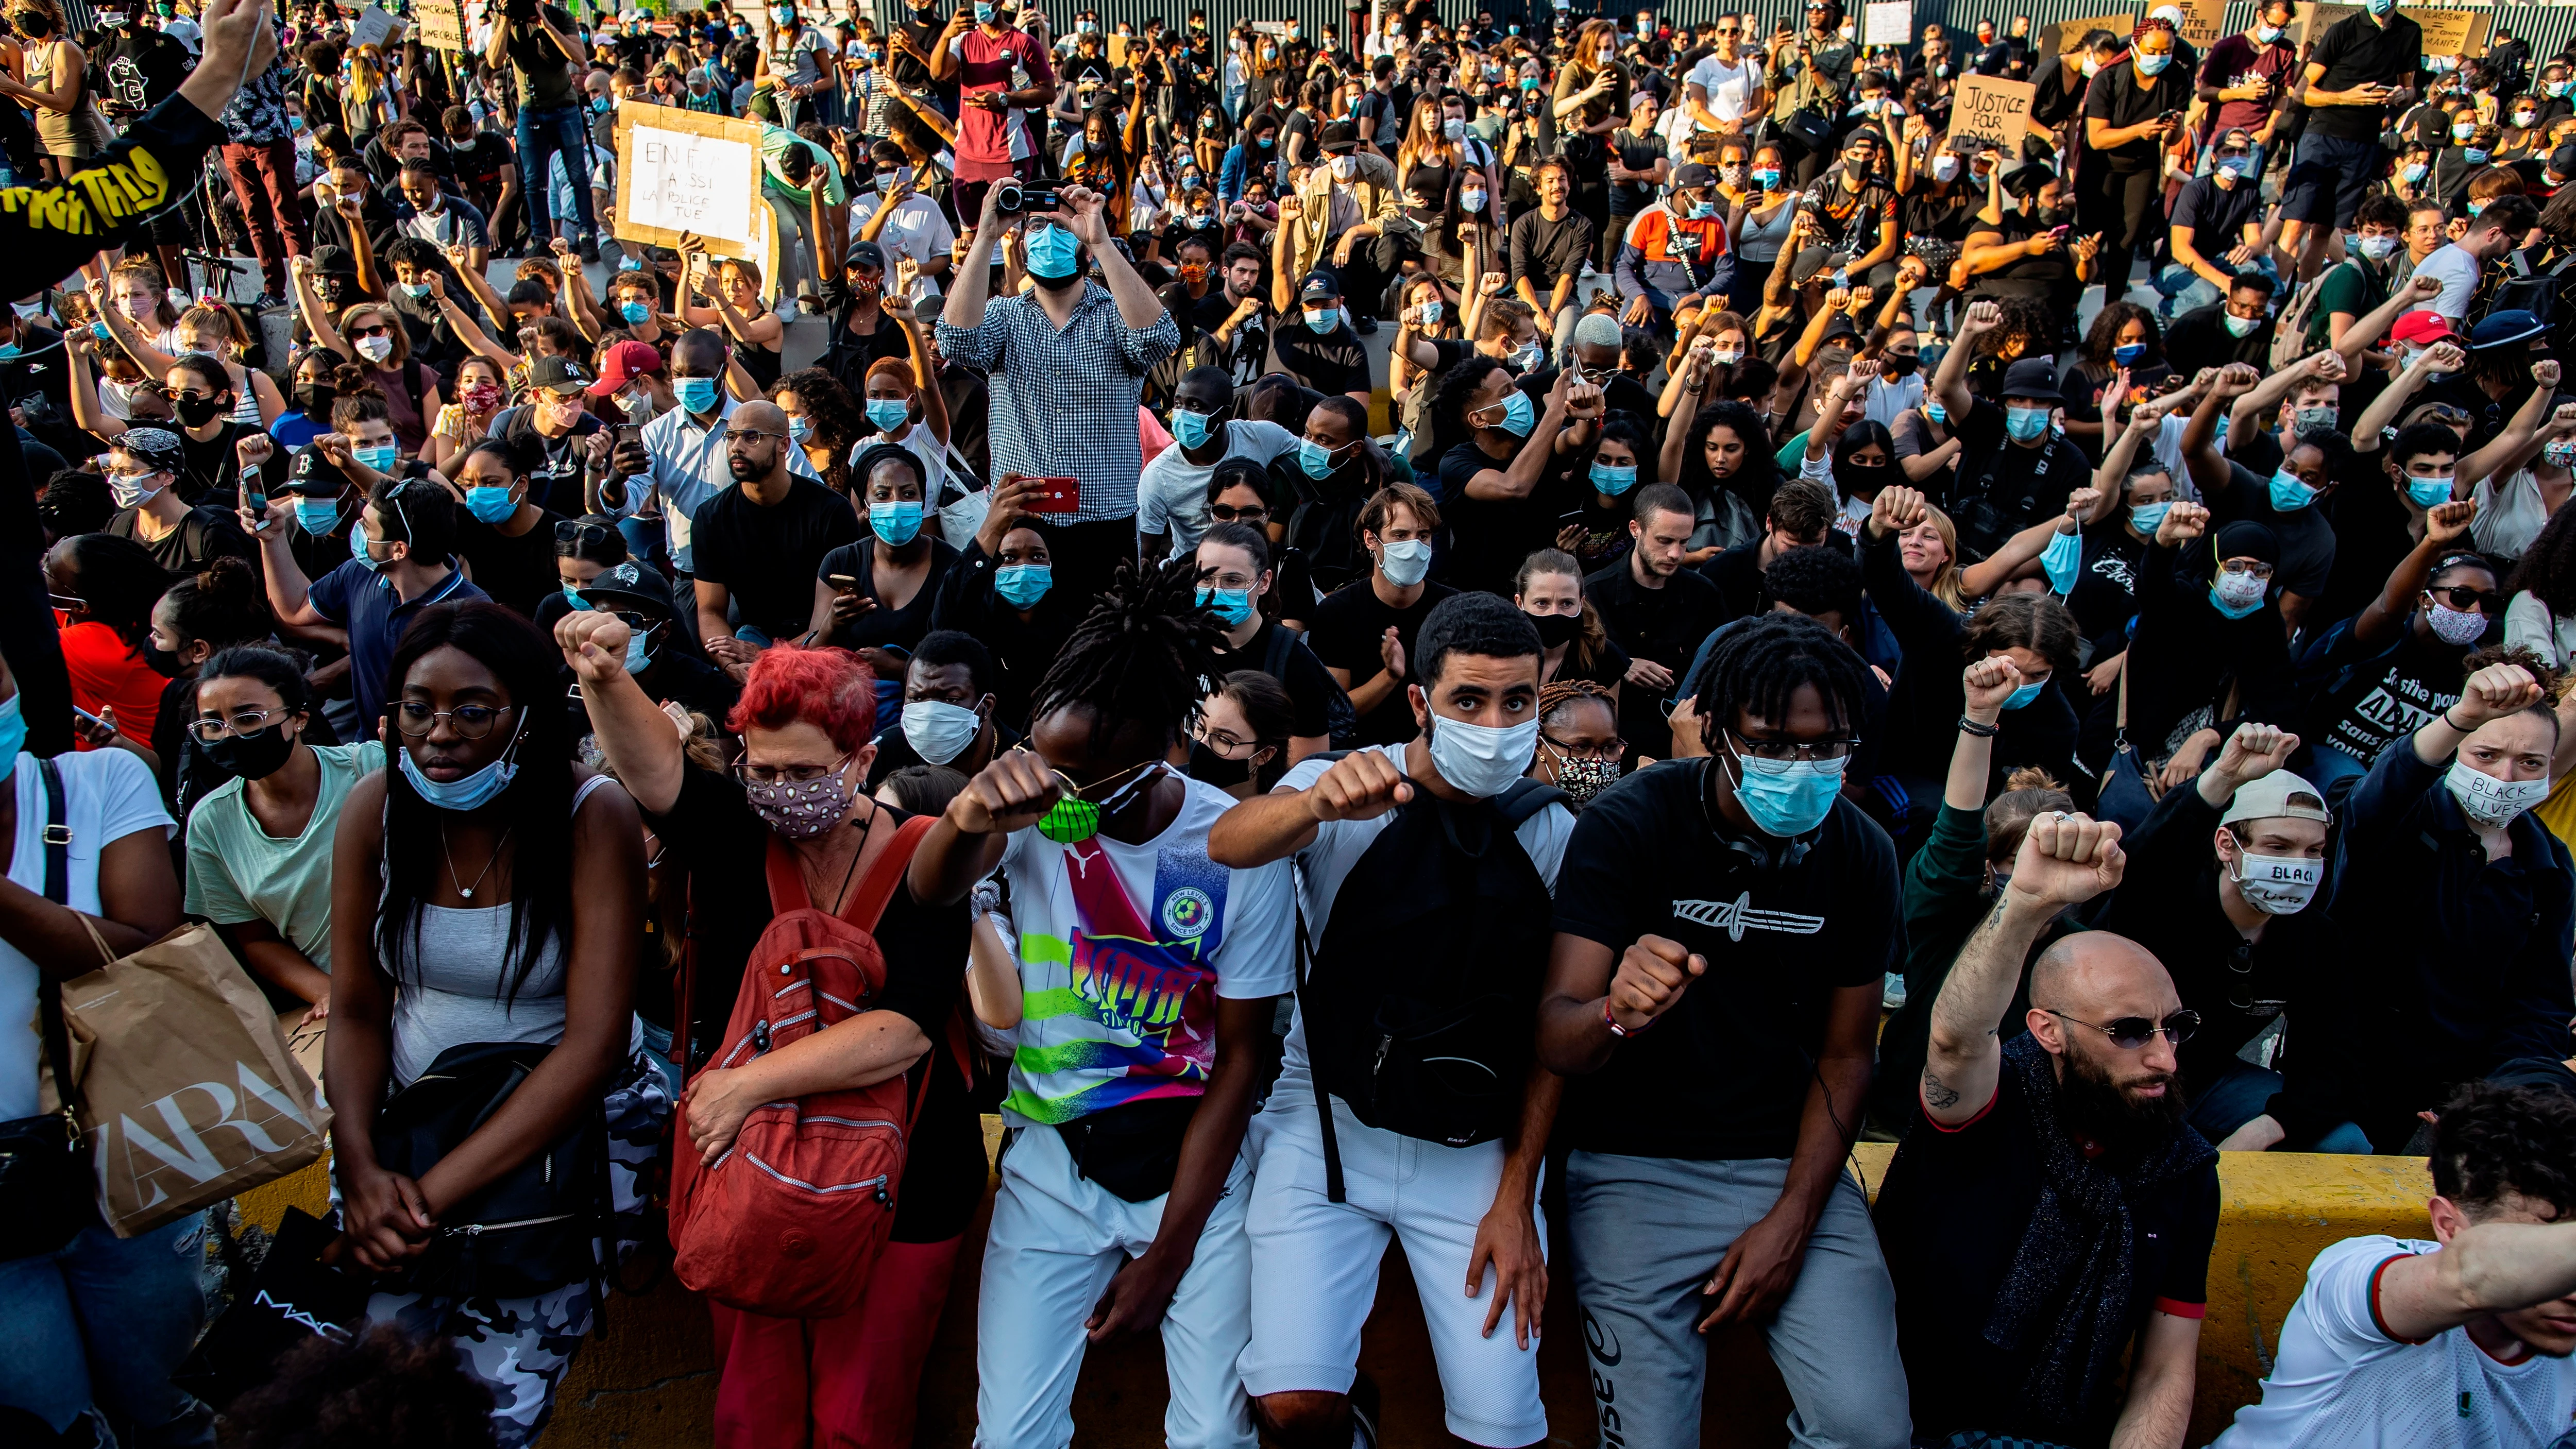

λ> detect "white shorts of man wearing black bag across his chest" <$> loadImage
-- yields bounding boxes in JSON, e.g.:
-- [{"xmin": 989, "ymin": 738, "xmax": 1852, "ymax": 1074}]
[{"xmin": 1242, "ymin": 1091, "xmax": 1548, "ymax": 1444}]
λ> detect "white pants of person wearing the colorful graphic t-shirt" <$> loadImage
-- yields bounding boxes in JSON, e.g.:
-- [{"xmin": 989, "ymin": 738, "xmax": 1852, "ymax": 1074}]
[{"xmin": 974, "ymin": 1127, "xmax": 1257, "ymax": 1449}]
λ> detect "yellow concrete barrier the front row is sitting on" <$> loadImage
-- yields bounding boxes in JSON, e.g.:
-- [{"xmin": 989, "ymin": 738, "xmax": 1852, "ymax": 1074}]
[{"xmin": 240, "ymin": 1137, "xmax": 2432, "ymax": 1449}]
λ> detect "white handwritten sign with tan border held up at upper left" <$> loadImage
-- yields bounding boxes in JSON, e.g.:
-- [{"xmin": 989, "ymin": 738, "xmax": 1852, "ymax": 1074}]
[{"xmin": 618, "ymin": 100, "xmax": 768, "ymax": 258}]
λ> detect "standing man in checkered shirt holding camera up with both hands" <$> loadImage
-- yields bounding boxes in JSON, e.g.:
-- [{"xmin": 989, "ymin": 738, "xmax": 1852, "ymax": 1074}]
[{"xmin": 938, "ymin": 185, "xmax": 1180, "ymax": 597}]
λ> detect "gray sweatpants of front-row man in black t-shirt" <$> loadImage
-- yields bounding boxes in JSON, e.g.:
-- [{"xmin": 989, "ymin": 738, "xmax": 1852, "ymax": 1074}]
[{"xmin": 1566, "ymin": 1153, "xmax": 1914, "ymax": 1449}]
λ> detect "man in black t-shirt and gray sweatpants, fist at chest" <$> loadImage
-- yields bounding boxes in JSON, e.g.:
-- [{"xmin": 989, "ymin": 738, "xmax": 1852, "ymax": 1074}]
[{"xmin": 1538, "ymin": 612, "xmax": 1911, "ymax": 1444}]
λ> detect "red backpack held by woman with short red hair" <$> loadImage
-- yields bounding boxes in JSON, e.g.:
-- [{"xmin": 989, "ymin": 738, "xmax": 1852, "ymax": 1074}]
[{"xmin": 670, "ymin": 816, "xmax": 940, "ymax": 1318}]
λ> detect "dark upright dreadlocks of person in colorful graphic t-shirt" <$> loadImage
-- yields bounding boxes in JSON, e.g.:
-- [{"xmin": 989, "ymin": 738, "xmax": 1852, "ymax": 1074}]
[{"xmin": 1028, "ymin": 556, "xmax": 1226, "ymax": 744}]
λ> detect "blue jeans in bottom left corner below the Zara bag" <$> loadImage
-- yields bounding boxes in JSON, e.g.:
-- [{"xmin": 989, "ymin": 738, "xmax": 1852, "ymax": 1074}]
[{"xmin": 0, "ymin": 1212, "xmax": 214, "ymax": 1449}]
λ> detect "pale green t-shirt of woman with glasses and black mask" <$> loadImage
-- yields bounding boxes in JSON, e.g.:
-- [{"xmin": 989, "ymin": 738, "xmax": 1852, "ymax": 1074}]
[{"xmin": 188, "ymin": 744, "xmax": 381, "ymax": 973}]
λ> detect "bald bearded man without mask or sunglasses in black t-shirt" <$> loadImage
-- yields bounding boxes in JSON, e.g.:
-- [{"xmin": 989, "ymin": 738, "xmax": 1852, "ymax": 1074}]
[{"xmin": 690, "ymin": 401, "xmax": 866, "ymax": 679}]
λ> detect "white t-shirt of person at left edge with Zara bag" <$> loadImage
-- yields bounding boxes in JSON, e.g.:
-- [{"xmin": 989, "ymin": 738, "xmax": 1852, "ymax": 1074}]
[{"xmin": 0, "ymin": 749, "xmax": 178, "ymax": 1122}]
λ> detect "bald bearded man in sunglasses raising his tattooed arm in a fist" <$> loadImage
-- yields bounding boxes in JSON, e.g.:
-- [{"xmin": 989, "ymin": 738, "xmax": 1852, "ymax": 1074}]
[{"xmin": 1878, "ymin": 813, "xmax": 2218, "ymax": 1449}]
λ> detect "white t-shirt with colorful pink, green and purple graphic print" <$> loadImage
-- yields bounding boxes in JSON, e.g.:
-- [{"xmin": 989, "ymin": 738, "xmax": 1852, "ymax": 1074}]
[{"xmin": 1002, "ymin": 780, "xmax": 1296, "ymax": 1127}]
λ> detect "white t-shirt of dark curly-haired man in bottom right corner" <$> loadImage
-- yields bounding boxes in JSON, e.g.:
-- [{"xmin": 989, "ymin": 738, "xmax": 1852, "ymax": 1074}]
[{"xmin": 2210, "ymin": 1233, "xmax": 2576, "ymax": 1449}]
